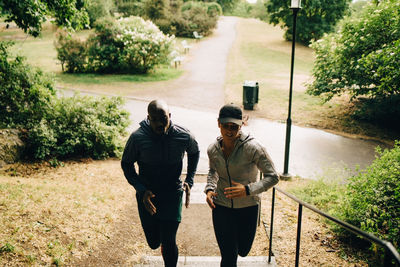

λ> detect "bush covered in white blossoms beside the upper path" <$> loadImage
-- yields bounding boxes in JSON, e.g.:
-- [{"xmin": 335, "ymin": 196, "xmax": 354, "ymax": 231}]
[{"xmin": 116, "ymin": 17, "xmax": 175, "ymax": 73}]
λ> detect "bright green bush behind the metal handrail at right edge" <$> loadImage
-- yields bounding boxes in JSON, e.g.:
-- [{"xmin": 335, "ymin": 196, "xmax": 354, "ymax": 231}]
[{"xmin": 337, "ymin": 141, "xmax": 400, "ymax": 253}]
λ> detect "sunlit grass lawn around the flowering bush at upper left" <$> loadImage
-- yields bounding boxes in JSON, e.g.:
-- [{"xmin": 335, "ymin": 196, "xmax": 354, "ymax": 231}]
[{"xmin": 0, "ymin": 24, "xmax": 183, "ymax": 92}]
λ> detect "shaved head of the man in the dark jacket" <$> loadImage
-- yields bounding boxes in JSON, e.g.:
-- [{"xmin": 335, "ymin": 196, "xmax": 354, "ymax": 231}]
[{"xmin": 147, "ymin": 100, "xmax": 171, "ymax": 135}]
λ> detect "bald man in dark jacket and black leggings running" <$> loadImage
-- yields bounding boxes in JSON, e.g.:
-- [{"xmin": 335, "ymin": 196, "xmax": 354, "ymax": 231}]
[{"xmin": 121, "ymin": 100, "xmax": 200, "ymax": 267}]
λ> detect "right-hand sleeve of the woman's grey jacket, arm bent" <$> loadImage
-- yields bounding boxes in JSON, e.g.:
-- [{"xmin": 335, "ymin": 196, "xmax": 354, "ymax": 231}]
[{"xmin": 248, "ymin": 143, "xmax": 279, "ymax": 195}]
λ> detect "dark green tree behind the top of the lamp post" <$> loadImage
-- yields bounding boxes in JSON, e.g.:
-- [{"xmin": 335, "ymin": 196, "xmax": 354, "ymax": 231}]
[{"xmin": 265, "ymin": 0, "xmax": 351, "ymax": 45}]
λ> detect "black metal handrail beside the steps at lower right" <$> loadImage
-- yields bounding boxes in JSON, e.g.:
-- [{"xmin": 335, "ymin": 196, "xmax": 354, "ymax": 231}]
[{"xmin": 268, "ymin": 186, "xmax": 400, "ymax": 267}]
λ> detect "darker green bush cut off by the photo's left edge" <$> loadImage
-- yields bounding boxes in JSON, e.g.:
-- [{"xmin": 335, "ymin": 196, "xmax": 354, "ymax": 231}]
[{"xmin": 0, "ymin": 42, "xmax": 55, "ymax": 127}]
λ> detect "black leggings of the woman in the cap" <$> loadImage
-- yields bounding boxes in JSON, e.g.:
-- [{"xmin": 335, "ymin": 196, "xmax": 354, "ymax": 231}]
[{"xmin": 212, "ymin": 205, "xmax": 258, "ymax": 267}]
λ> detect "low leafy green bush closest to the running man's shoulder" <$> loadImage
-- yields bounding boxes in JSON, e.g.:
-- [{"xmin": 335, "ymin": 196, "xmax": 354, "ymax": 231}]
[{"xmin": 27, "ymin": 95, "xmax": 129, "ymax": 159}]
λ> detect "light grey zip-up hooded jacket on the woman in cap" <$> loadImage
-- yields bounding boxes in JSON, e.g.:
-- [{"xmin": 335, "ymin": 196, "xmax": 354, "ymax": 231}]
[{"xmin": 204, "ymin": 132, "xmax": 279, "ymax": 208}]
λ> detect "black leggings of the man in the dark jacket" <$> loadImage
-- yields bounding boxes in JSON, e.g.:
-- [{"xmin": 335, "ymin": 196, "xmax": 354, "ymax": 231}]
[{"xmin": 137, "ymin": 196, "xmax": 179, "ymax": 267}]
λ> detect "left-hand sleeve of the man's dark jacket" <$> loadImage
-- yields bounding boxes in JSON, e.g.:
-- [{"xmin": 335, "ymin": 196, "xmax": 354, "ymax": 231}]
[{"xmin": 121, "ymin": 135, "xmax": 146, "ymax": 191}]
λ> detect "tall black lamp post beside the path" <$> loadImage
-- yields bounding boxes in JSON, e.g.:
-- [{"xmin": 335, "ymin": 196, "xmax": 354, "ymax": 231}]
[{"xmin": 281, "ymin": 0, "xmax": 301, "ymax": 179}]
